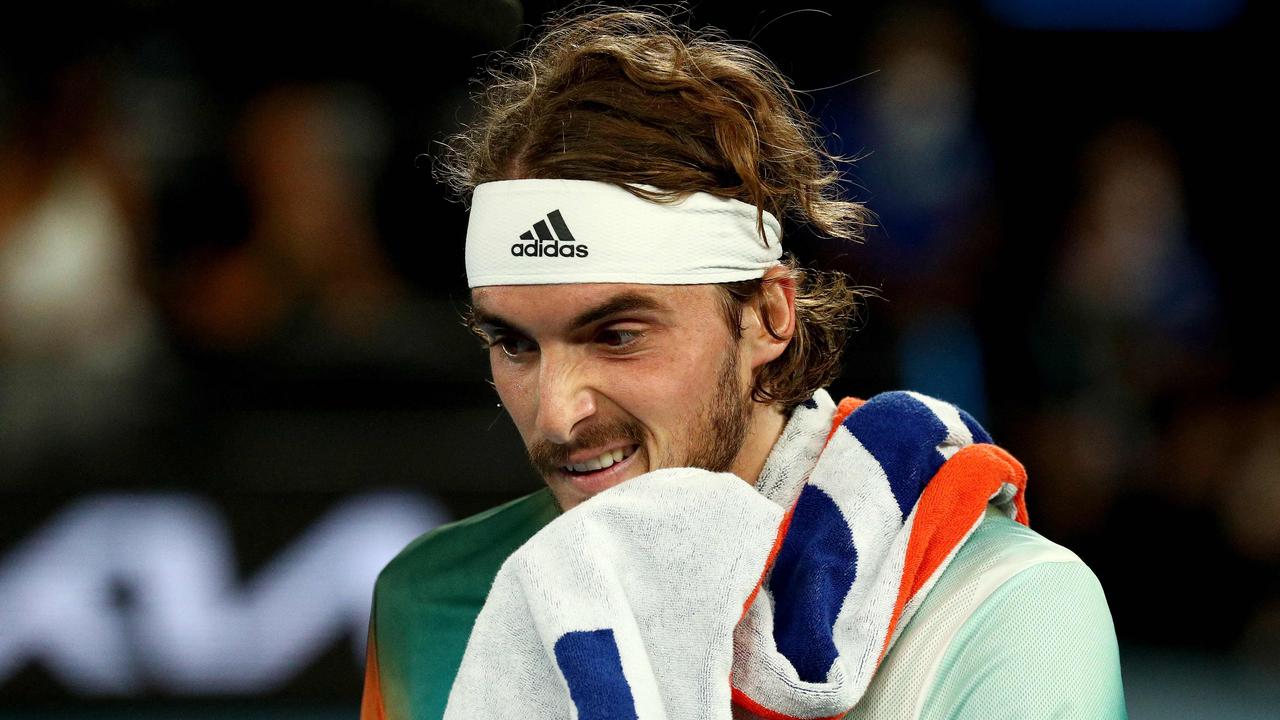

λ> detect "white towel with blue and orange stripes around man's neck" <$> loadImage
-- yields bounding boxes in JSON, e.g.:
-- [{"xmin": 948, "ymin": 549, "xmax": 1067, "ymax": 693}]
[{"xmin": 445, "ymin": 391, "xmax": 1027, "ymax": 720}]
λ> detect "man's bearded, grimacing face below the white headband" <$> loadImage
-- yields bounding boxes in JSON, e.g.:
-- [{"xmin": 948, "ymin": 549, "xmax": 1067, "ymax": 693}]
[{"xmin": 472, "ymin": 283, "xmax": 753, "ymax": 510}]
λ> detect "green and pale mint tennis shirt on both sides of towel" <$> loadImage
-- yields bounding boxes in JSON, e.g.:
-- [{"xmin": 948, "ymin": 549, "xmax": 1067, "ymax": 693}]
[{"xmin": 362, "ymin": 489, "xmax": 1125, "ymax": 720}]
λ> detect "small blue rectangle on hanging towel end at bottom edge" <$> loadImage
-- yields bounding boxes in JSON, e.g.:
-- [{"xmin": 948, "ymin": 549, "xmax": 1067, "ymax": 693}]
[{"xmin": 556, "ymin": 628, "xmax": 637, "ymax": 720}]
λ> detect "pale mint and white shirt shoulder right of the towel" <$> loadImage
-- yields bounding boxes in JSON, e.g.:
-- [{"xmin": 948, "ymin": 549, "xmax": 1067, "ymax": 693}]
[{"xmin": 849, "ymin": 507, "xmax": 1124, "ymax": 720}]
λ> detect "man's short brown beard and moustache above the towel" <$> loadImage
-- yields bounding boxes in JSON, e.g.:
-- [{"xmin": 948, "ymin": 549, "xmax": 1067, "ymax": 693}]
[{"xmin": 529, "ymin": 343, "xmax": 751, "ymax": 478}]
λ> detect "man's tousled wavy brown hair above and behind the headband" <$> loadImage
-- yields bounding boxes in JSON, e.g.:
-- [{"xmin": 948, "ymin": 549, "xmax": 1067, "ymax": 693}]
[{"xmin": 436, "ymin": 6, "xmax": 873, "ymax": 407}]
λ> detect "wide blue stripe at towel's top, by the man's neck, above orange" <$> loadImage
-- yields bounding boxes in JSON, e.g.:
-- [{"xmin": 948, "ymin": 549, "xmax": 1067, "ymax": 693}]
[{"xmin": 844, "ymin": 391, "xmax": 952, "ymax": 518}]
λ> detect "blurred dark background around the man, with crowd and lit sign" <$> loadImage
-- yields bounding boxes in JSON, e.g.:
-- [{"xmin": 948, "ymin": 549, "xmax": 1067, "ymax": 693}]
[{"xmin": 0, "ymin": 0, "xmax": 1280, "ymax": 719}]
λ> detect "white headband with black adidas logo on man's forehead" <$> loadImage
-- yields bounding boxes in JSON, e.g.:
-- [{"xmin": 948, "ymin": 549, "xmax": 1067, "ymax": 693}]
[{"xmin": 467, "ymin": 179, "xmax": 782, "ymax": 287}]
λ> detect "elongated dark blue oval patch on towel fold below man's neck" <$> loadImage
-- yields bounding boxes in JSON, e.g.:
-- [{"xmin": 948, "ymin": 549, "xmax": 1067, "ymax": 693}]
[{"xmin": 769, "ymin": 486, "xmax": 858, "ymax": 683}]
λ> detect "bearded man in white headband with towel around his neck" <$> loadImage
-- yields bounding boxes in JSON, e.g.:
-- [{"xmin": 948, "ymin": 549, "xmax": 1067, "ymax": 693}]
[{"xmin": 362, "ymin": 10, "xmax": 1124, "ymax": 719}]
